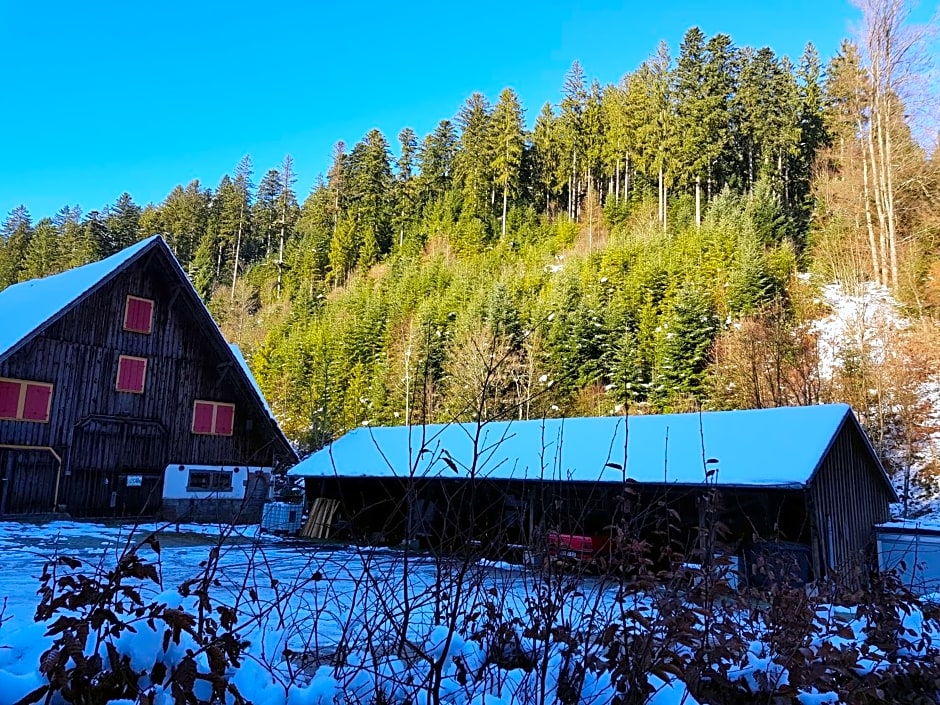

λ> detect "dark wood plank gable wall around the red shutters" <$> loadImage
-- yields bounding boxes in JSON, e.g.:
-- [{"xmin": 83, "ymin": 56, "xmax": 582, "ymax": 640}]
[{"xmin": 0, "ymin": 243, "xmax": 292, "ymax": 514}]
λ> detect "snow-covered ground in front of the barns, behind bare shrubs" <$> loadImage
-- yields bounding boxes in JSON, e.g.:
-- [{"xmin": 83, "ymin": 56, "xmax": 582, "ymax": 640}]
[{"xmin": 0, "ymin": 522, "xmax": 938, "ymax": 705}]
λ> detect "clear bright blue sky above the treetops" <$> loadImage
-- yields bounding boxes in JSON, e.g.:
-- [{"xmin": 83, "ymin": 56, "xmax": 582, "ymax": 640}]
[{"xmin": 0, "ymin": 0, "xmax": 858, "ymax": 221}]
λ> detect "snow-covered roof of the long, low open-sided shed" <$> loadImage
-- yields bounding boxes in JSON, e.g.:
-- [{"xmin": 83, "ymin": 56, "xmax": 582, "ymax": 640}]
[{"xmin": 289, "ymin": 404, "xmax": 887, "ymax": 487}]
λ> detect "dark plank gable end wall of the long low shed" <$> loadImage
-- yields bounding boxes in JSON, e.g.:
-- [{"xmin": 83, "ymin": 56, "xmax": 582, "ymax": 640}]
[{"xmin": 809, "ymin": 420, "xmax": 892, "ymax": 571}]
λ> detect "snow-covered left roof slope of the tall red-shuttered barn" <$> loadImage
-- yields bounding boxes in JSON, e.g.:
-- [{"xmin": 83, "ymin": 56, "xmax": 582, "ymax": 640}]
[{"xmin": 0, "ymin": 235, "xmax": 159, "ymax": 357}]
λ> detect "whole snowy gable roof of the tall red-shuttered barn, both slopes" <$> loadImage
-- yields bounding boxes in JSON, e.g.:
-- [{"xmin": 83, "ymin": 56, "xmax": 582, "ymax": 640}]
[{"xmin": 0, "ymin": 235, "xmax": 297, "ymax": 460}]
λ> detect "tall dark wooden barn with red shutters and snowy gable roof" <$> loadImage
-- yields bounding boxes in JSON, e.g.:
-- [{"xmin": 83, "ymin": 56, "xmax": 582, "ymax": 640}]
[{"xmin": 0, "ymin": 236, "xmax": 296, "ymax": 519}]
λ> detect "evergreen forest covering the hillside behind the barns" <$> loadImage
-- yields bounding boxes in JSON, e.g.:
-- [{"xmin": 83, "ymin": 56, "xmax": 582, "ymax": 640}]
[{"xmin": 0, "ymin": 9, "xmax": 940, "ymax": 500}]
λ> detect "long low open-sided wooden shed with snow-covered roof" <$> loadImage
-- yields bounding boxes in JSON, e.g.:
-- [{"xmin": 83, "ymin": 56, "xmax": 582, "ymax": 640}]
[{"xmin": 289, "ymin": 404, "xmax": 897, "ymax": 579}]
